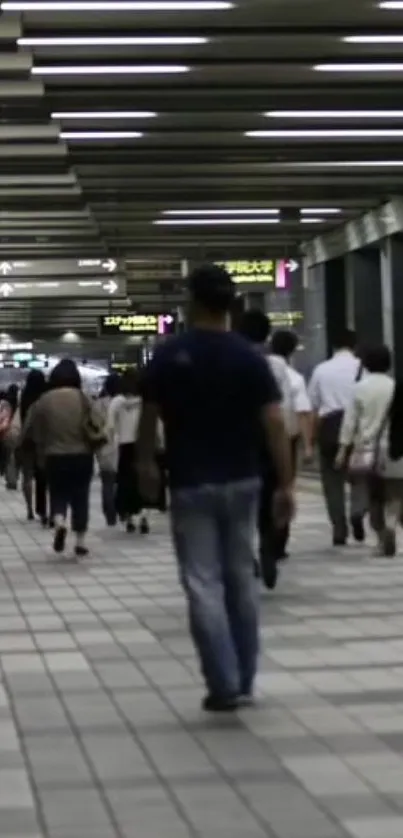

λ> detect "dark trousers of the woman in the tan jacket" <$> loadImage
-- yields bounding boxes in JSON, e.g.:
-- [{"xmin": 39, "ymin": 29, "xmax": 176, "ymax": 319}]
[{"xmin": 46, "ymin": 454, "xmax": 93, "ymax": 534}]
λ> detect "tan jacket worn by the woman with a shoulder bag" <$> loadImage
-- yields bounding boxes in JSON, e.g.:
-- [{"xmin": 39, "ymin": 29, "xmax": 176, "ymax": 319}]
[{"xmin": 22, "ymin": 387, "xmax": 91, "ymax": 457}]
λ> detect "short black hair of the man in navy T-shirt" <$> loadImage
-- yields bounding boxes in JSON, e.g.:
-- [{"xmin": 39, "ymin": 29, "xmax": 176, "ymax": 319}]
[{"xmin": 188, "ymin": 264, "xmax": 235, "ymax": 314}]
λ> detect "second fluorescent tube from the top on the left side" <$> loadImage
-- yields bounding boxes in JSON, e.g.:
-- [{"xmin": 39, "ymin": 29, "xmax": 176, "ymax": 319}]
[{"xmin": 18, "ymin": 35, "xmax": 208, "ymax": 47}]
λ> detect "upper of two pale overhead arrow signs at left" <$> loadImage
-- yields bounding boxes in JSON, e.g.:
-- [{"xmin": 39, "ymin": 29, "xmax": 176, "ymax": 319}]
[{"xmin": 0, "ymin": 256, "xmax": 120, "ymax": 279}]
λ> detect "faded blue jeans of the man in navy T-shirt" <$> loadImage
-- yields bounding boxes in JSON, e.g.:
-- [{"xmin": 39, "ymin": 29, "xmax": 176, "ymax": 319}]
[{"xmin": 171, "ymin": 480, "xmax": 259, "ymax": 697}]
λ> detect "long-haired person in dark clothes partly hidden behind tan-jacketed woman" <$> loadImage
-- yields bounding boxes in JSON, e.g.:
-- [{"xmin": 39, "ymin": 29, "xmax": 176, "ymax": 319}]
[{"xmin": 20, "ymin": 370, "xmax": 47, "ymax": 526}]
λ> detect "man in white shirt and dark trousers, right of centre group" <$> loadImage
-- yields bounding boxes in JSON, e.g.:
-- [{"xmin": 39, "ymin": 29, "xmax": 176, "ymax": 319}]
[{"xmin": 308, "ymin": 329, "xmax": 366, "ymax": 546}]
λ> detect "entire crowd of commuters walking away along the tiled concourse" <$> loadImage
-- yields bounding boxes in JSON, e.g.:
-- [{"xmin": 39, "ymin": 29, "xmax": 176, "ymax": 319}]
[{"xmin": 0, "ymin": 265, "xmax": 403, "ymax": 712}]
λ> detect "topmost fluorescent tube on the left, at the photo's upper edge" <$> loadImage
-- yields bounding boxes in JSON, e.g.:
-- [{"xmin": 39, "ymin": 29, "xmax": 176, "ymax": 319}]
[{"xmin": 1, "ymin": 0, "xmax": 234, "ymax": 12}]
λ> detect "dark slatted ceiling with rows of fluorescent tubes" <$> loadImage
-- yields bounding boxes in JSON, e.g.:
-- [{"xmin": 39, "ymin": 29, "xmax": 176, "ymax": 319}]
[{"xmin": 0, "ymin": 0, "xmax": 403, "ymax": 334}]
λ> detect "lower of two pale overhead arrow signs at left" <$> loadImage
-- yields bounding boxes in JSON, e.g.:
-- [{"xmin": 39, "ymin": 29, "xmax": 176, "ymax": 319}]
[{"xmin": 0, "ymin": 276, "xmax": 127, "ymax": 300}]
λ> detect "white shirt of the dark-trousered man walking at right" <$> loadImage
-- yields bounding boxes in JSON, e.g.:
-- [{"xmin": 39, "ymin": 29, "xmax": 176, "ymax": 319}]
[{"xmin": 308, "ymin": 349, "xmax": 361, "ymax": 416}]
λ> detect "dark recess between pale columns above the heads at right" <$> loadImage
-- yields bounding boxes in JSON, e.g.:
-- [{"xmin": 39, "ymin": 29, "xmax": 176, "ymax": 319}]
[{"xmin": 346, "ymin": 248, "xmax": 383, "ymax": 346}]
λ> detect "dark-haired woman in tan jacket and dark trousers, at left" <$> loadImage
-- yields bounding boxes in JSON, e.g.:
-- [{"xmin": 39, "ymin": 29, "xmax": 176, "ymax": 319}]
[{"xmin": 23, "ymin": 359, "xmax": 100, "ymax": 557}]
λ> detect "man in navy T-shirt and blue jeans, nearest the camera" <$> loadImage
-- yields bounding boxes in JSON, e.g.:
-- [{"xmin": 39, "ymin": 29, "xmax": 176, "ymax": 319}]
[{"xmin": 138, "ymin": 265, "xmax": 293, "ymax": 712}]
